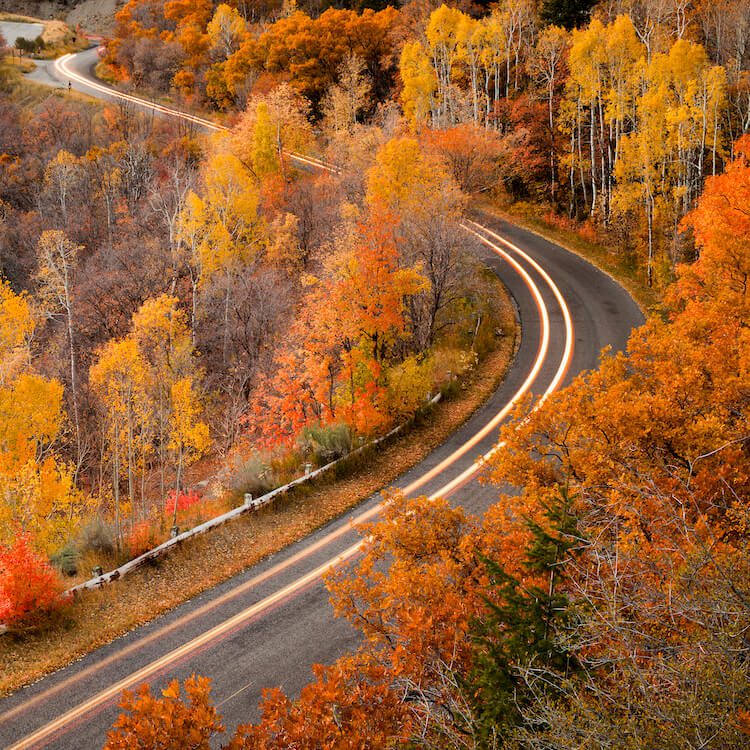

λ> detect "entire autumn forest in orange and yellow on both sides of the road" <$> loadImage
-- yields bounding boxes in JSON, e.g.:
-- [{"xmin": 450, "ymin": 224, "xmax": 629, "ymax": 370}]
[{"xmin": 0, "ymin": 0, "xmax": 750, "ymax": 750}]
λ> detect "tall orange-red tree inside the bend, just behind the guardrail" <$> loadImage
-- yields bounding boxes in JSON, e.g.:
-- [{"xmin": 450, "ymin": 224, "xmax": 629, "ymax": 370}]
[{"xmin": 244, "ymin": 212, "xmax": 426, "ymax": 446}]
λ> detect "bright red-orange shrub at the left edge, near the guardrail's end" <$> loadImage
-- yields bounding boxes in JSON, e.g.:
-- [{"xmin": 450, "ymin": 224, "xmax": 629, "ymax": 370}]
[{"xmin": 0, "ymin": 533, "xmax": 66, "ymax": 630}]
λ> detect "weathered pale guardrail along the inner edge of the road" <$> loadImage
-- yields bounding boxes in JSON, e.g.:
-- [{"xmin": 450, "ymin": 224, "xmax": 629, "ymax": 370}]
[{"xmin": 65, "ymin": 393, "xmax": 442, "ymax": 596}]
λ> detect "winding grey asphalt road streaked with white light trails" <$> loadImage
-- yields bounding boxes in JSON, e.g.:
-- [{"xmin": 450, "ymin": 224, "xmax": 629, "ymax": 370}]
[{"xmin": 0, "ymin": 51, "xmax": 643, "ymax": 750}]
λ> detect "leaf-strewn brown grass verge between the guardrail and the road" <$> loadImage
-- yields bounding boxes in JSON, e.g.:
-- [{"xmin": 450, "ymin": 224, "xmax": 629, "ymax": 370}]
[{"xmin": 0, "ymin": 281, "xmax": 515, "ymax": 695}]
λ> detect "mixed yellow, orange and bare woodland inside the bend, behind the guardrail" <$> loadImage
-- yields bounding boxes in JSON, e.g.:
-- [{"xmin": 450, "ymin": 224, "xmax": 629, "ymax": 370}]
[{"xmin": 2, "ymin": 35, "xmax": 506, "ymax": 588}]
